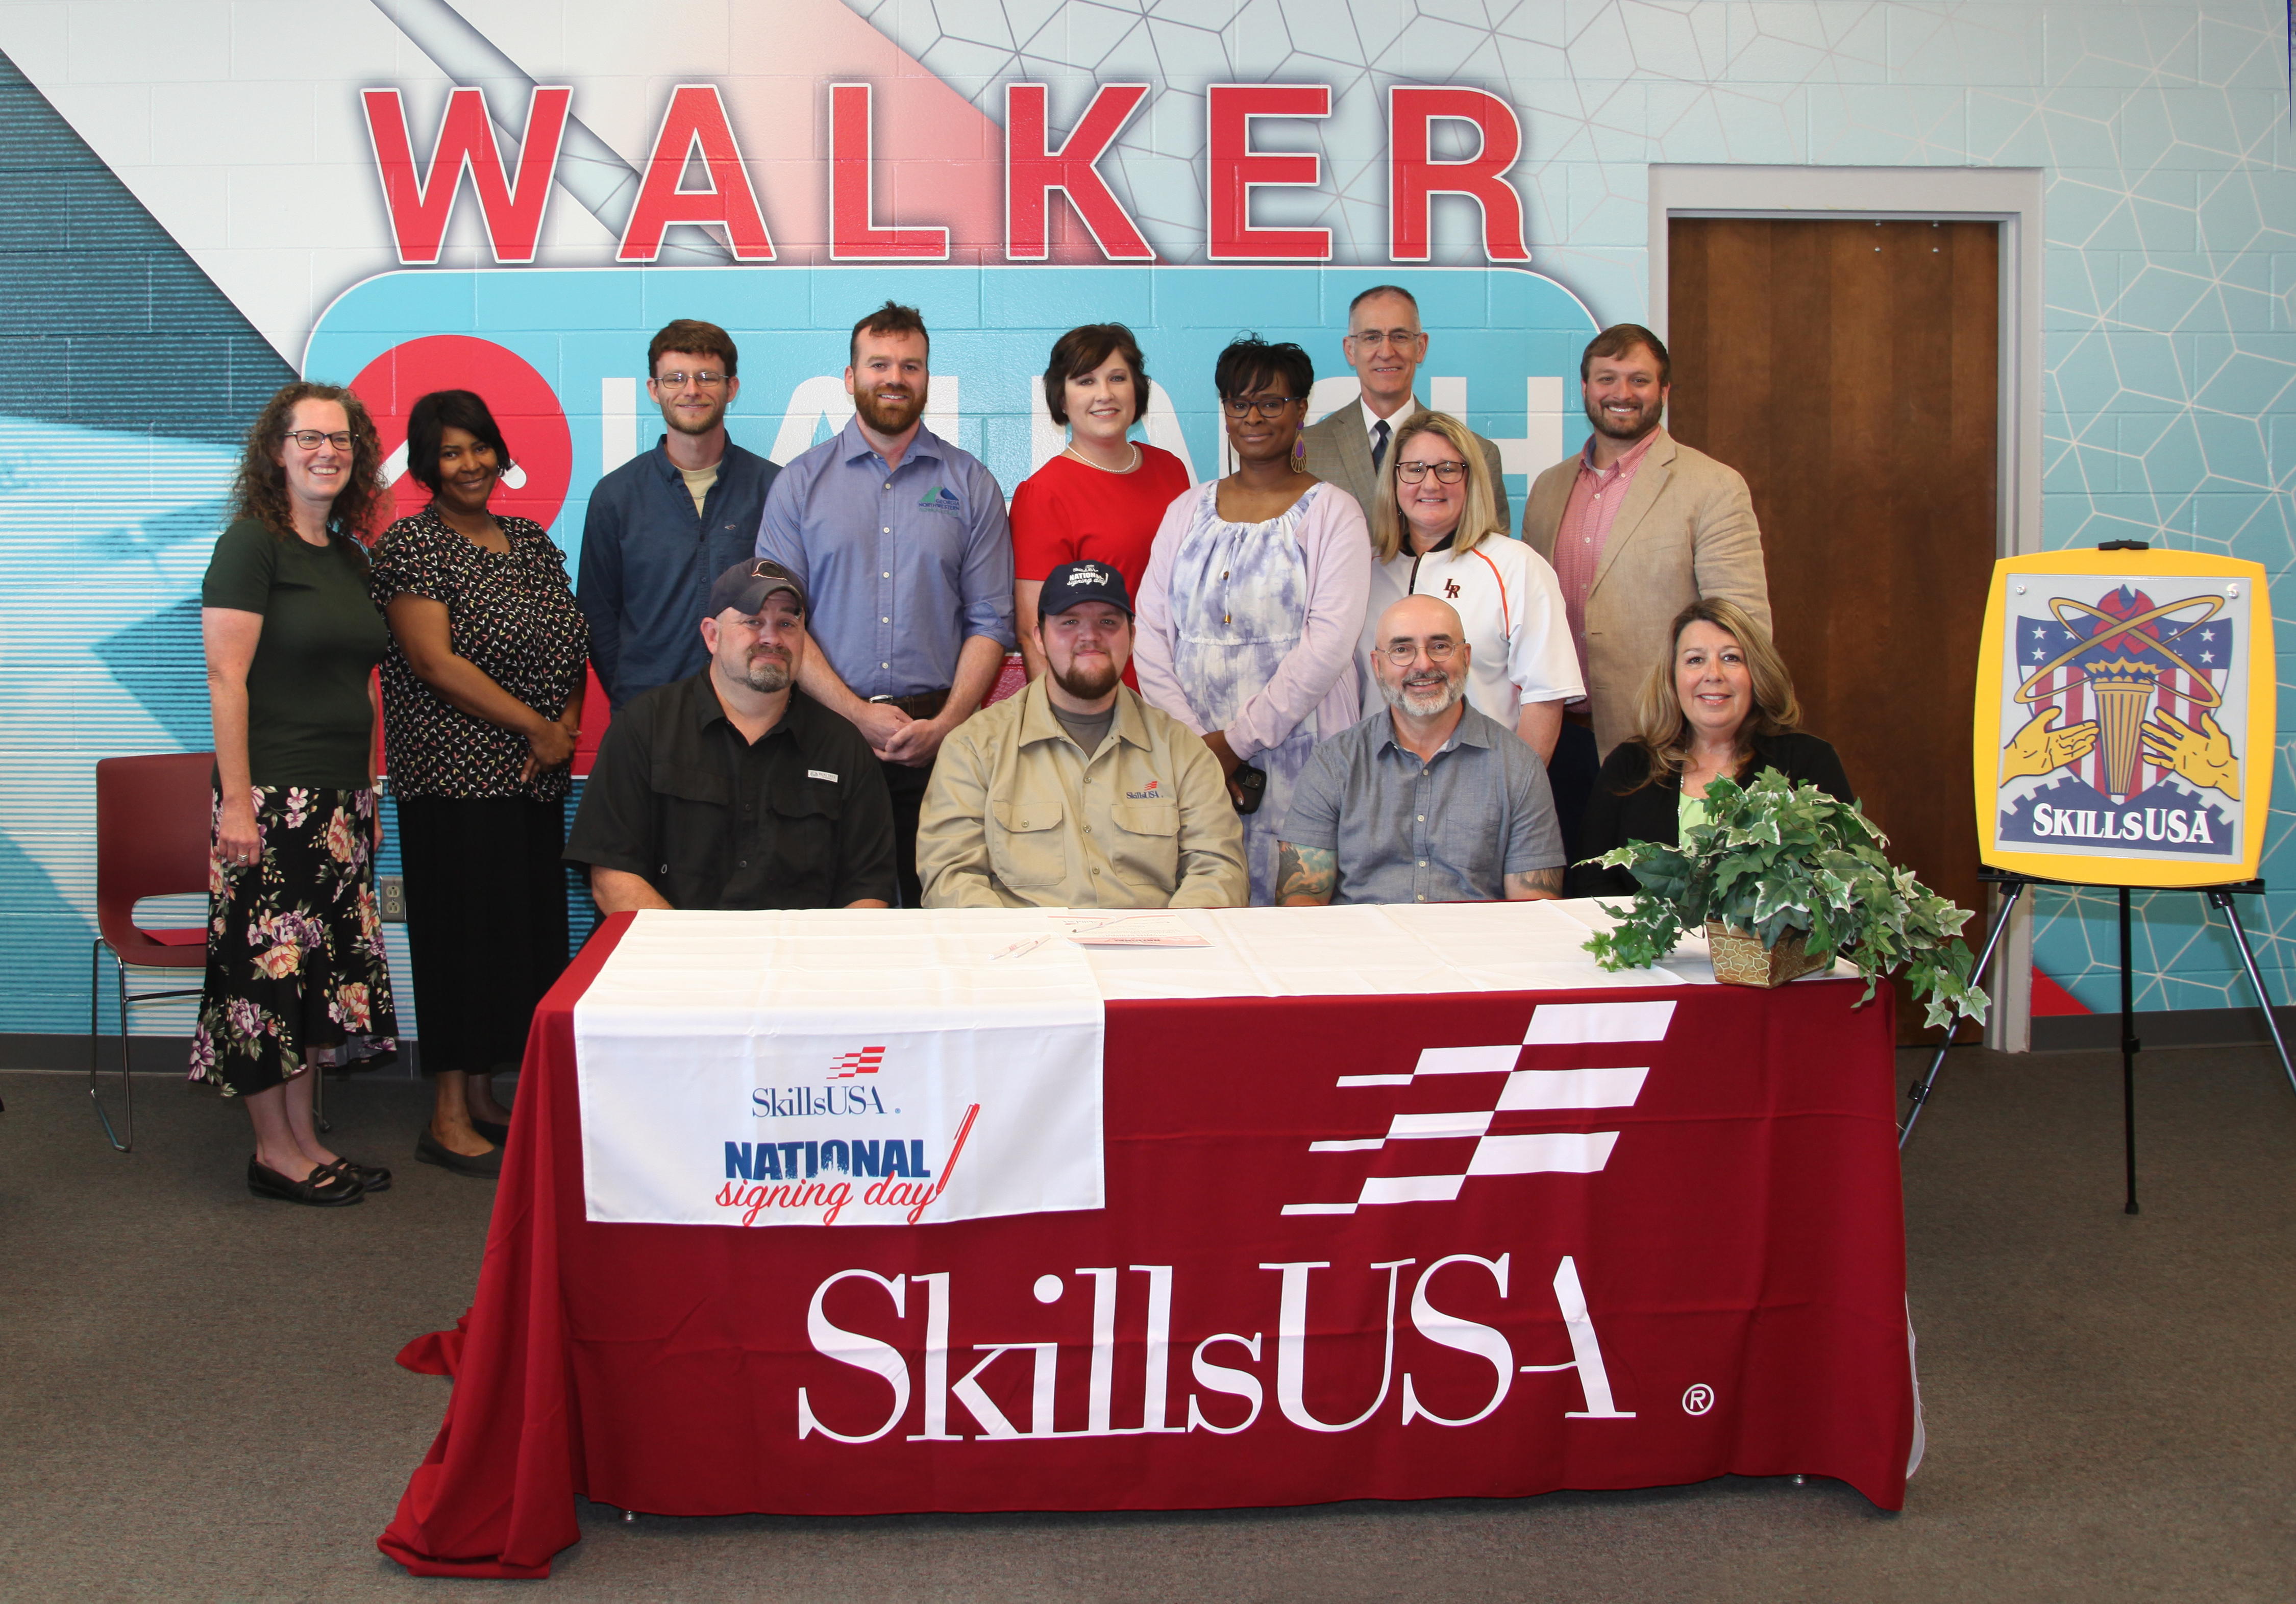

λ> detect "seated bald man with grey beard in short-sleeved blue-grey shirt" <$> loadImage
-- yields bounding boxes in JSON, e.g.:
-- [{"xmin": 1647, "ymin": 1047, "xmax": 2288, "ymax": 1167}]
[{"xmin": 1276, "ymin": 597, "xmax": 1564, "ymax": 909}]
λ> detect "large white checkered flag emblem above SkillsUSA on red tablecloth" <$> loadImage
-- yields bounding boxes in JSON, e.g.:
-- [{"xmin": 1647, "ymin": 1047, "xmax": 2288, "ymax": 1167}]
[{"xmin": 1283, "ymin": 1003, "xmax": 1674, "ymax": 1214}]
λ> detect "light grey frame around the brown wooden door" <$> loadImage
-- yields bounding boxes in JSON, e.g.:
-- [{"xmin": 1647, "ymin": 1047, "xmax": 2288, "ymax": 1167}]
[{"xmin": 1648, "ymin": 163, "xmax": 2046, "ymax": 1053}]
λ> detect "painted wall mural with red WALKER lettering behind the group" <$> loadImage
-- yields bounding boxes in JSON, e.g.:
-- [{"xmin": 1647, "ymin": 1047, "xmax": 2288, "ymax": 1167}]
[{"xmin": 0, "ymin": 0, "xmax": 2296, "ymax": 1030}]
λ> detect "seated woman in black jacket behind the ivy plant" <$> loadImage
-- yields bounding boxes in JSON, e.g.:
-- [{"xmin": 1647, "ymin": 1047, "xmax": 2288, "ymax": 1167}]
[{"xmin": 1568, "ymin": 597, "xmax": 1858, "ymax": 897}]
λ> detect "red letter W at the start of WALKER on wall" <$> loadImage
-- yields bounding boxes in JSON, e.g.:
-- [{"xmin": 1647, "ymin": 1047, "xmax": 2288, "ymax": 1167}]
[{"xmin": 360, "ymin": 87, "xmax": 574, "ymax": 266}]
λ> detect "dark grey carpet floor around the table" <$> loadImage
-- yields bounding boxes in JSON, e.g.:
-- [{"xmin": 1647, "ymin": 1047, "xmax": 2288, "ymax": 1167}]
[{"xmin": 0, "ymin": 1049, "xmax": 2296, "ymax": 1604}]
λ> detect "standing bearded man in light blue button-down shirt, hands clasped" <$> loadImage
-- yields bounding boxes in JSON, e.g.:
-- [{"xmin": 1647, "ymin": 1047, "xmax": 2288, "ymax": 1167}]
[{"xmin": 758, "ymin": 301, "xmax": 1013, "ymax": 909}]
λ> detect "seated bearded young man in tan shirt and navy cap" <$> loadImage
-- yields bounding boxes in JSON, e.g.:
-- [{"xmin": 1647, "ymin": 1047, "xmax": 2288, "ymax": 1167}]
[{"xmin": 916, "ymin": 562, "xmax": 1251, "ymax": 909}]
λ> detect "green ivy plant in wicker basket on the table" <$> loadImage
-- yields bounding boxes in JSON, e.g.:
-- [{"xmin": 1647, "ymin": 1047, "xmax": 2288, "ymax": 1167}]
[{"xmin": 1587, "ymin": 769, "xmax": 1988, "ymax": 1026}]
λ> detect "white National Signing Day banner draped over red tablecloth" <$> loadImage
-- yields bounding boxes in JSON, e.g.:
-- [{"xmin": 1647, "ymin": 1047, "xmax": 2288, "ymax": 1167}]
[{"xmin": 574, "ymin": 909, "xmax": 1104, "ymax": 1225}]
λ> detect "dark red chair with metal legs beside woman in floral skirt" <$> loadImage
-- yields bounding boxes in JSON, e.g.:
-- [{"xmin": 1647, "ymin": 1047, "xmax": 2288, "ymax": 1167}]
[{"xmin": 87, "ymin": 753, "xmax": 216, "ymax": 1152}]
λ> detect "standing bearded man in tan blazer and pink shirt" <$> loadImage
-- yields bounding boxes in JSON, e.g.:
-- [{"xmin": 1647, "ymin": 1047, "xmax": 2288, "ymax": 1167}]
[{"xmin": 1522, "ymin": 324, "xmax": 1770, "ymax": 755}]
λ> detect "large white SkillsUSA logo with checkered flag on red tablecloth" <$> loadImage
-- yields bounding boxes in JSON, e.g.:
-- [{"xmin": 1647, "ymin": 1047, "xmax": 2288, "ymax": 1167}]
[{"xmin": 789, "ymin": 1003, "xmax": 1671, "ymax": 1443}]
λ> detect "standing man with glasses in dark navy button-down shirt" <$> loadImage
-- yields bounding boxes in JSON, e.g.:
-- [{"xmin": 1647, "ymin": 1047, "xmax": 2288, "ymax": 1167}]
[{"xmin": 576, "ymin": 317, "xmax": 781, "ymax": 711}]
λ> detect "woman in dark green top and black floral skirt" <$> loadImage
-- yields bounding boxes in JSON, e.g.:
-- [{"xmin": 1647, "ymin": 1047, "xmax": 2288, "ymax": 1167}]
[{"xmin": 190, "ymin": 383, "xmax": 397, "ymax": 1207}]
